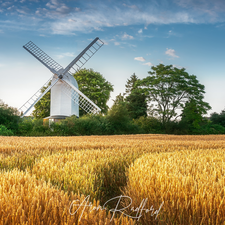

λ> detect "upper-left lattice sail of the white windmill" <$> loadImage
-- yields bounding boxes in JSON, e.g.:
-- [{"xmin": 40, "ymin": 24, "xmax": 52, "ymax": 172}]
[{"xmin": 23, "ymin": 41, "xmax": 63, "ymax": 74}]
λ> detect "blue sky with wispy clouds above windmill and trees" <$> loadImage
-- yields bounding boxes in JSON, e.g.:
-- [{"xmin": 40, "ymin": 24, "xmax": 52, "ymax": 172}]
[{"xmin": 0, "ymin": 0, "xmax": 225, "ymax": 115}]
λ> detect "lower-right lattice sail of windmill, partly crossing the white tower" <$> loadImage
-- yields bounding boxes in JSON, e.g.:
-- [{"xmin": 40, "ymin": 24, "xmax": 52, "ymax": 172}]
[{"xmin": 60, "ymin": 79, "xmax": 101, "ymax": 114}]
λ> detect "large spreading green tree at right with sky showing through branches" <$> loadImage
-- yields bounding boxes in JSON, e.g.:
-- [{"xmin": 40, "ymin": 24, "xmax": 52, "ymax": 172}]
[{"xmin": 139, "ymin": 64, "xmax": 211, "ymax": 126}]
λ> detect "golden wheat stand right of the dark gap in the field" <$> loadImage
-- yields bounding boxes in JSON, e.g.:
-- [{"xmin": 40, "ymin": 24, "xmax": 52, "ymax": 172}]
[{"xmin": 124, "ymin": 149, "xmax": 225, "ymax": 225}]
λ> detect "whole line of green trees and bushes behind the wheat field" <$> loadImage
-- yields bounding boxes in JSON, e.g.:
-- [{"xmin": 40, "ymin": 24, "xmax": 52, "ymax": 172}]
[{"xmin": 0, "ymin": 64, "xmax": 225, "ymax": 136}]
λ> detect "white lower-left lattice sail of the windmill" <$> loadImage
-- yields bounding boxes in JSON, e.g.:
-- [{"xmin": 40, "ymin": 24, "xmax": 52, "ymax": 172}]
[{"xmin": 19, "ymin": 77, "xmax": 59, "ymax": 118}]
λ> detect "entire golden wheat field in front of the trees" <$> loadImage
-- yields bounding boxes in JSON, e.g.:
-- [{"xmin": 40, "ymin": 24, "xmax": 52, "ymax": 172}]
[{"xmin": 0, "ymin": 135, "xmax": 225, "ymax": 225}]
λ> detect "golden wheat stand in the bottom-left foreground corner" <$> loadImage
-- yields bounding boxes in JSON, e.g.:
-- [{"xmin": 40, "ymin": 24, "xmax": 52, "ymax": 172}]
[{"xmin": 0, "ymin": 169, "xmax": 133, "ymax": 225}]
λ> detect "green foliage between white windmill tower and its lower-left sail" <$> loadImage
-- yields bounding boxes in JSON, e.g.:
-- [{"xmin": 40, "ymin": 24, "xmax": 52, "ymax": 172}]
[{"xmin": 32, "ymin": 83, "xmax": 51, "ymax": 119}]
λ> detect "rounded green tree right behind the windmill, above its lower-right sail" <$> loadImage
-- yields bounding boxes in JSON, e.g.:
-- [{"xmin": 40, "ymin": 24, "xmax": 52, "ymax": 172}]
[{"xmin": 73, "ymin": 69, "xmax": 113, "ymax": 116}]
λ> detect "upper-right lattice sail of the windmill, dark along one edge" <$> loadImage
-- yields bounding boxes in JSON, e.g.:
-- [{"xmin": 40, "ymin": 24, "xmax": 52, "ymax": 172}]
[{"xmin": 63, "ymin": 38, "xmax": 104, "ymax": 75}]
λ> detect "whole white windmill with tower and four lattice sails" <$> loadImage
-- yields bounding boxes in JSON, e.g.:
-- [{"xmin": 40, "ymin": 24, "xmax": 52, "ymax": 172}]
[{"xmin": 19, "ymin": 38, "xmax": 104, "ymax": 121}]
